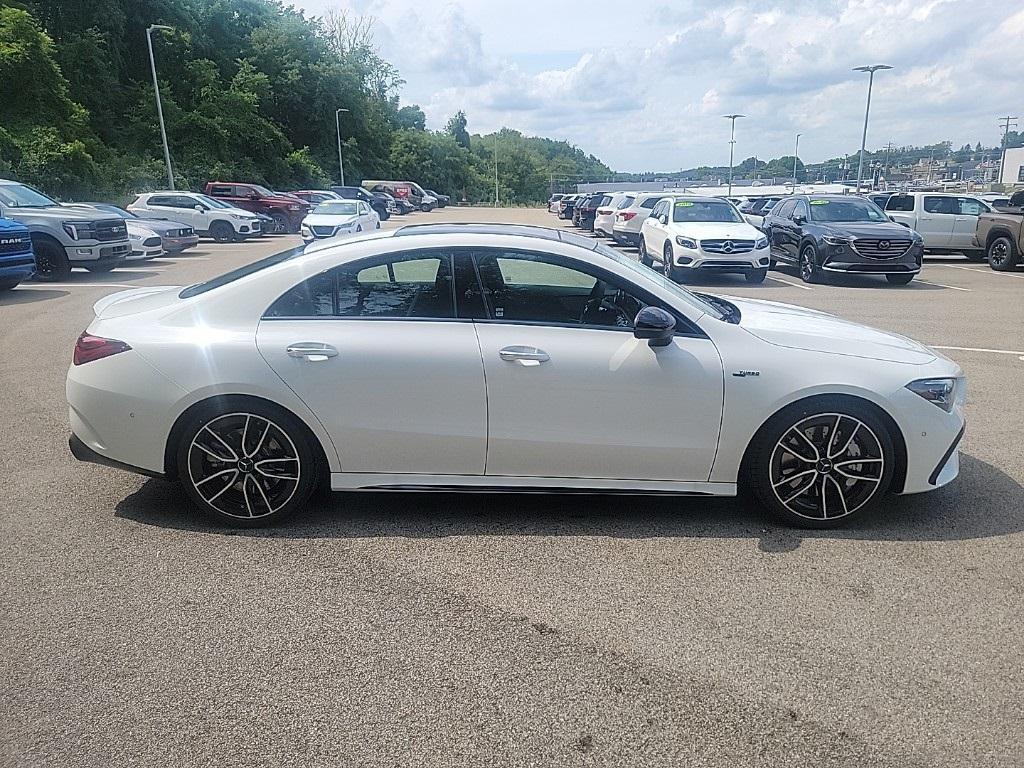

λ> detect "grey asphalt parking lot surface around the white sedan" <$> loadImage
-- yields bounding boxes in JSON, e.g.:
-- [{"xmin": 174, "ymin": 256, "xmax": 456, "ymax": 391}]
[{"xmin": 0, "ymin": 208, "xmax": 1024, "ymax": 768}]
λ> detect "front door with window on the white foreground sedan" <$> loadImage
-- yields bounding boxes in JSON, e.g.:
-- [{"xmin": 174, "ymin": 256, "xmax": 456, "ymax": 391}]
[{"xmin": 475, "ymin": 250, "xmax": 723, "ymax": 481}]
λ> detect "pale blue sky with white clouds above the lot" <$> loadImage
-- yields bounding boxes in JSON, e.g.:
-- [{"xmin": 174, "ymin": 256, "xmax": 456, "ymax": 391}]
[{"xmin": 292, "ymin": 0, "xmax": 1024, "ymax": 172}]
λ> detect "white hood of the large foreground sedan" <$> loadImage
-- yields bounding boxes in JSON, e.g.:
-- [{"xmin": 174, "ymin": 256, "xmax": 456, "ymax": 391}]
[{"xmin": 723, "ymin": 296, "xmax": 938, "ymax": 366}]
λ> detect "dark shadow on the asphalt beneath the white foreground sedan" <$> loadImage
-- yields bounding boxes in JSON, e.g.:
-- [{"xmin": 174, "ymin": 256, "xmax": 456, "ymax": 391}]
[{"xmin": 116, "ymin": 455, "xmax": 1024, "ymax": 552}]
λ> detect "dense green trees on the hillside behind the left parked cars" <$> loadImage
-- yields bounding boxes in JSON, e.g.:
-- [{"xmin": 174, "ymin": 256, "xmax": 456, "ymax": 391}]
[{"xmin": 0, "ymin": 0, "xmax": 612, "ymax": 204}]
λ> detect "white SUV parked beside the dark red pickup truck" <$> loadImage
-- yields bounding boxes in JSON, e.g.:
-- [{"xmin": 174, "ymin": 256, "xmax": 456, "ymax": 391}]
[{"xmin": 128, "ymin": 191, "xmax": 261, "ymax": 243}]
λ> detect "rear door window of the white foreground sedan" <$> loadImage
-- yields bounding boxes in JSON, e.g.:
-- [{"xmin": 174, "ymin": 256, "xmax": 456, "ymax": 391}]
[{"xmin": 265, "ymin": 252, "xmax": 455, "ymax": 319}]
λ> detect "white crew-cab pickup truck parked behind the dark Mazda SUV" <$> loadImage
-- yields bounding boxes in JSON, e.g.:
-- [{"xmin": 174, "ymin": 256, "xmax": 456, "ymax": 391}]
[{"xmin": 886, "ymin": 193, "xmax": 992, "ymax": 261}]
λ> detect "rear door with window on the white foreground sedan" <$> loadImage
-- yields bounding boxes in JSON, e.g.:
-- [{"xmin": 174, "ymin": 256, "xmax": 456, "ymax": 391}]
[{"xmin": 257, "ymin": 251, "xmax": 487, "ymax": 475}]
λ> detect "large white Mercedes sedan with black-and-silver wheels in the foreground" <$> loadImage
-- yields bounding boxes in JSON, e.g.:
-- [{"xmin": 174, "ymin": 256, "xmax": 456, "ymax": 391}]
[{"xmin": 67, "ymin": 224, "xmax": 965, "ymax": 527}]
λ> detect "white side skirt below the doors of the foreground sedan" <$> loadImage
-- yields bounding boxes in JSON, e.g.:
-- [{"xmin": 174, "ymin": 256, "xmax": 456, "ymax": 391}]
[{"xmin": 331, "ymin": 472, "xmax": 736, "ymax": 496}]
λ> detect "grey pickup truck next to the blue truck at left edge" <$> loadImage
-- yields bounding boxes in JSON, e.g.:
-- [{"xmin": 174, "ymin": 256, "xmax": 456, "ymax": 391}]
[{"xmin": 0, "ymin": 179, "xmax": 131, "ymax": 281}]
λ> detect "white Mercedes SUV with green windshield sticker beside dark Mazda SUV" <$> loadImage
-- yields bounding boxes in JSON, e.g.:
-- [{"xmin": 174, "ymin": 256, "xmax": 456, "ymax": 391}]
[{"xmin": 640, "ymin": 196, "xmax": 771, "ymax": 283}]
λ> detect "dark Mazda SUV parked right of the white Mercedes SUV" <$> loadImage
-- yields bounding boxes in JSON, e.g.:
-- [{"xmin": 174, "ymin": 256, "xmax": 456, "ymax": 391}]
[{"xmin": 762, "ymin": 195, "xmax": 925, "ymax": 286}]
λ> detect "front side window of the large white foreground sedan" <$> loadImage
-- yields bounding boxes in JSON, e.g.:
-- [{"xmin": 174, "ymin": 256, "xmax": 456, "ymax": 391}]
[{"xmin": 476, "ymin": 251, "xmax": 646, "ymax": 329}]
